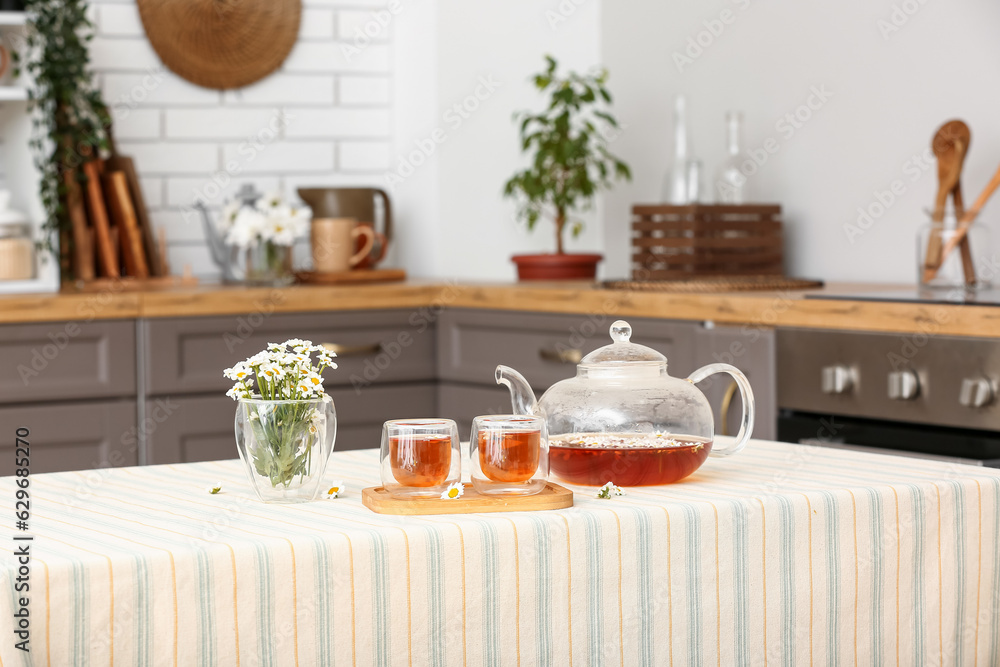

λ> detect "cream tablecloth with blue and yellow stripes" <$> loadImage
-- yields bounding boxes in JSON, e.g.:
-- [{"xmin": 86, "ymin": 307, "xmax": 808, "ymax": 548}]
[{"xmin": 0, "ymin": 441, "xmax": 1000, "ymax": 667}]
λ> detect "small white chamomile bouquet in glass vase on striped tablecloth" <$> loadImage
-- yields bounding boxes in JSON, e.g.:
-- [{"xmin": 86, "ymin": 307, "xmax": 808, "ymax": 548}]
[{"xmin": 223, "ymin": 338, "xmax": 337, "ymax": 502}]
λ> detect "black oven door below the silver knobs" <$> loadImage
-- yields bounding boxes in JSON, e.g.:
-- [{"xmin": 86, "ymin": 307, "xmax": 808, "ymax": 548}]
[{"xmin": 778, "ymin": 410, "xmax": 1000, "ymax": 468}]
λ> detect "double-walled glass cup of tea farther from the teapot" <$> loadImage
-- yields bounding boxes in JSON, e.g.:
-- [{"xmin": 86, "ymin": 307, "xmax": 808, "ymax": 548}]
[{"xmin": 381, "ymin": 419, "xmax": 462, "ymax": 498}]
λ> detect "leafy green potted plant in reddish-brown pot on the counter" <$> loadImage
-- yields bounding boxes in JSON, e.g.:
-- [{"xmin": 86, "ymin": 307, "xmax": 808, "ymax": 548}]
[{"xmin": 503, "ymin": 56, "xmax": 632, "ymax": 280}]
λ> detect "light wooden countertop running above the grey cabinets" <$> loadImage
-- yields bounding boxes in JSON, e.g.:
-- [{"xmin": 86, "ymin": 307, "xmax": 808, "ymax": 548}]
[{"xmin": 0, "ymin": 281, "xmax": 1000, "ymax": 338}]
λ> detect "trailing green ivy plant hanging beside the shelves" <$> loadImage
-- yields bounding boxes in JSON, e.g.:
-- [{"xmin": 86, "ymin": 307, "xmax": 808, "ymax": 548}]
[{"xmin": 14, "ymin": 0, "xmax": 111, "ymax": 268}]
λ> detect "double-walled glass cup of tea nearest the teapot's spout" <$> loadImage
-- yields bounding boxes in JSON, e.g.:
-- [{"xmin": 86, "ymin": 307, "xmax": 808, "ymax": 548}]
[{"xmin": 469, "ymin": 415, "xmax": 549, "ymax": 496}]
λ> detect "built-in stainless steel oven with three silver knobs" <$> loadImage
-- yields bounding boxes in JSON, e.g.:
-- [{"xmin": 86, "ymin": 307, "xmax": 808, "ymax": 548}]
[{"xmin": 776, "ymin": 329, "xmax": 1000, "ymax": 467}]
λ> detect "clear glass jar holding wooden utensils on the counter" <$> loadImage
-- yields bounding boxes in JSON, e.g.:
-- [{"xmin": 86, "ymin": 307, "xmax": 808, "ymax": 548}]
[{"xmin": 917, "ymin": 209, "xmax": 993, "ymax": 289}]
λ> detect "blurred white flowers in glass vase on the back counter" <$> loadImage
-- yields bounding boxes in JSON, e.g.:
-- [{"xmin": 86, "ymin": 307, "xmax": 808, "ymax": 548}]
[{"xmin": 216, "ymin": 193, "xmax": 312, "ymax": 284}]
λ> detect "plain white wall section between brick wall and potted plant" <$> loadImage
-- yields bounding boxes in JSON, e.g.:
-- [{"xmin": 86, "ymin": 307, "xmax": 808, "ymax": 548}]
[{"xmin": 392, "ymin": 0, "xmax": 602, "ymax": 280}]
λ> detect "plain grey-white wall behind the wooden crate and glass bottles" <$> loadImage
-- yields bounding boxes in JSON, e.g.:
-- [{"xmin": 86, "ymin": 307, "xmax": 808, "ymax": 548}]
[{"xmin": 600, "ymin": 0, "xmax": 1000, "ymax": 282}]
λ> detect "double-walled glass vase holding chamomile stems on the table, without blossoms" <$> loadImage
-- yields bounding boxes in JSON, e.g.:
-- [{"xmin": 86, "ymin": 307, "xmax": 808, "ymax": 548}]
[{"xmin": 236, "ymin": 397, "xmax": 337, "ymax": 503}]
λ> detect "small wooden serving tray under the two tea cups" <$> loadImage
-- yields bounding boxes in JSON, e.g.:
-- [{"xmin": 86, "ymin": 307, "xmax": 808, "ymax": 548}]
[{"xmin": 361, "ymin": 482, "xmax": 573, "ymax": 515}]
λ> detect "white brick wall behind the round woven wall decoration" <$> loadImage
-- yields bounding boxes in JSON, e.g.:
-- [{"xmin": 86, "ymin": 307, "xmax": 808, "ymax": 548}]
[{"xmin": 91, "ymin": 0, "xmax": 392, "ymax": 278}]
